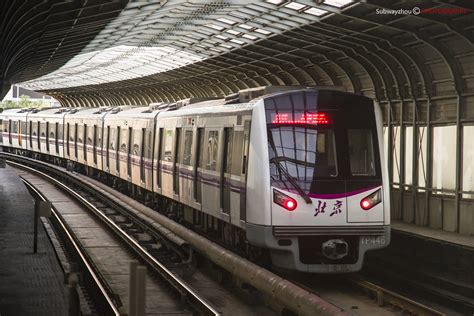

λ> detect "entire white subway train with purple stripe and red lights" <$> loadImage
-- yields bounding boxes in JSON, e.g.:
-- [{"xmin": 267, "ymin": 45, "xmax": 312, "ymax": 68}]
[{"xmin": 0, "ymin": 86, "xmax": 390, "ymax": 273}]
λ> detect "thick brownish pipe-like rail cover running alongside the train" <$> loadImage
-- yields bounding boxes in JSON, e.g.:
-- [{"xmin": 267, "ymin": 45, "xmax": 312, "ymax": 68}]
[{"xmin": 0, "ymin": 152, "xmax": 348, "ymax": 316}]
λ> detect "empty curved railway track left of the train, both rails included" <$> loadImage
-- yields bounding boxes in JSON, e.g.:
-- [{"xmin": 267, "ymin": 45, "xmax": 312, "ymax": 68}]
[{"xmin": 11, "ymin": 162, "xmax": 221, "ymax": 315}]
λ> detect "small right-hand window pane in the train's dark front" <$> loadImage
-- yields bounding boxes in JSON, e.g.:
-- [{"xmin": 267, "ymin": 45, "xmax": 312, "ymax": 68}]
[{"xmin": 348, "ymin": 129, "xmax": 375, "ymax": 176}]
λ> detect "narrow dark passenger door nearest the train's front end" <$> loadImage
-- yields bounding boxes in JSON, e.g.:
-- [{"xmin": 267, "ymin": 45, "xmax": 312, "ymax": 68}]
[{"xmin": 220, "ymin": 127, "xmax": 233, "ymax": 215}]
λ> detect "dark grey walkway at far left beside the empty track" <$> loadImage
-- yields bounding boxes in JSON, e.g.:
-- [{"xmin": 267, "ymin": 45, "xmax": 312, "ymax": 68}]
[{"xmin": 0, "ymin": 165, "xmax": 68, "ymax": 316}]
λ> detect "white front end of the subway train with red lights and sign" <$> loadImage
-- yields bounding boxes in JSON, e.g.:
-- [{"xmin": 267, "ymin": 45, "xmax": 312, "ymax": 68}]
[{"xmin": 247, "ymin": 89, "xmax": 390, "ymax": 273}]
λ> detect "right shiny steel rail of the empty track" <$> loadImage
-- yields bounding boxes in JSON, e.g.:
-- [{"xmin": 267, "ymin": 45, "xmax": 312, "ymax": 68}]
[{"xmin": 7, "ymin": 159, "xmax": 221, "ymax": 315}]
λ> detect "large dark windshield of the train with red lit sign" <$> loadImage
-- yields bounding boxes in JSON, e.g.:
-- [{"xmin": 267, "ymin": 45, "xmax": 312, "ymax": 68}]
[{"xmin": 264, "ymin": 90, "xmax": 381, "ymax": 197}]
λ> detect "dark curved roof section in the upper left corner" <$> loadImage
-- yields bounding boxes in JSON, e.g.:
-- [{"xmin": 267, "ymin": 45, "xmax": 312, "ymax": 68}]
[{"xmin": 0, "ymin": 0, "xmax": 127, "ymax": 99}]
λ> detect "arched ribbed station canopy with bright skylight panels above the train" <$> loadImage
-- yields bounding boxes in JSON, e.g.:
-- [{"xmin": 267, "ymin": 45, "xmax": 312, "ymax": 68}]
[{"xmin": 12, "ymin": 0, "xmax": 474, "ymax": 106}]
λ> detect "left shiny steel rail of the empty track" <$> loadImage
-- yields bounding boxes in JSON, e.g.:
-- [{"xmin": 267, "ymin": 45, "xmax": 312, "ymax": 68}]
[{"xmin": 19, "ymin": 174, "xmax": 120, "ymax": 316}]
